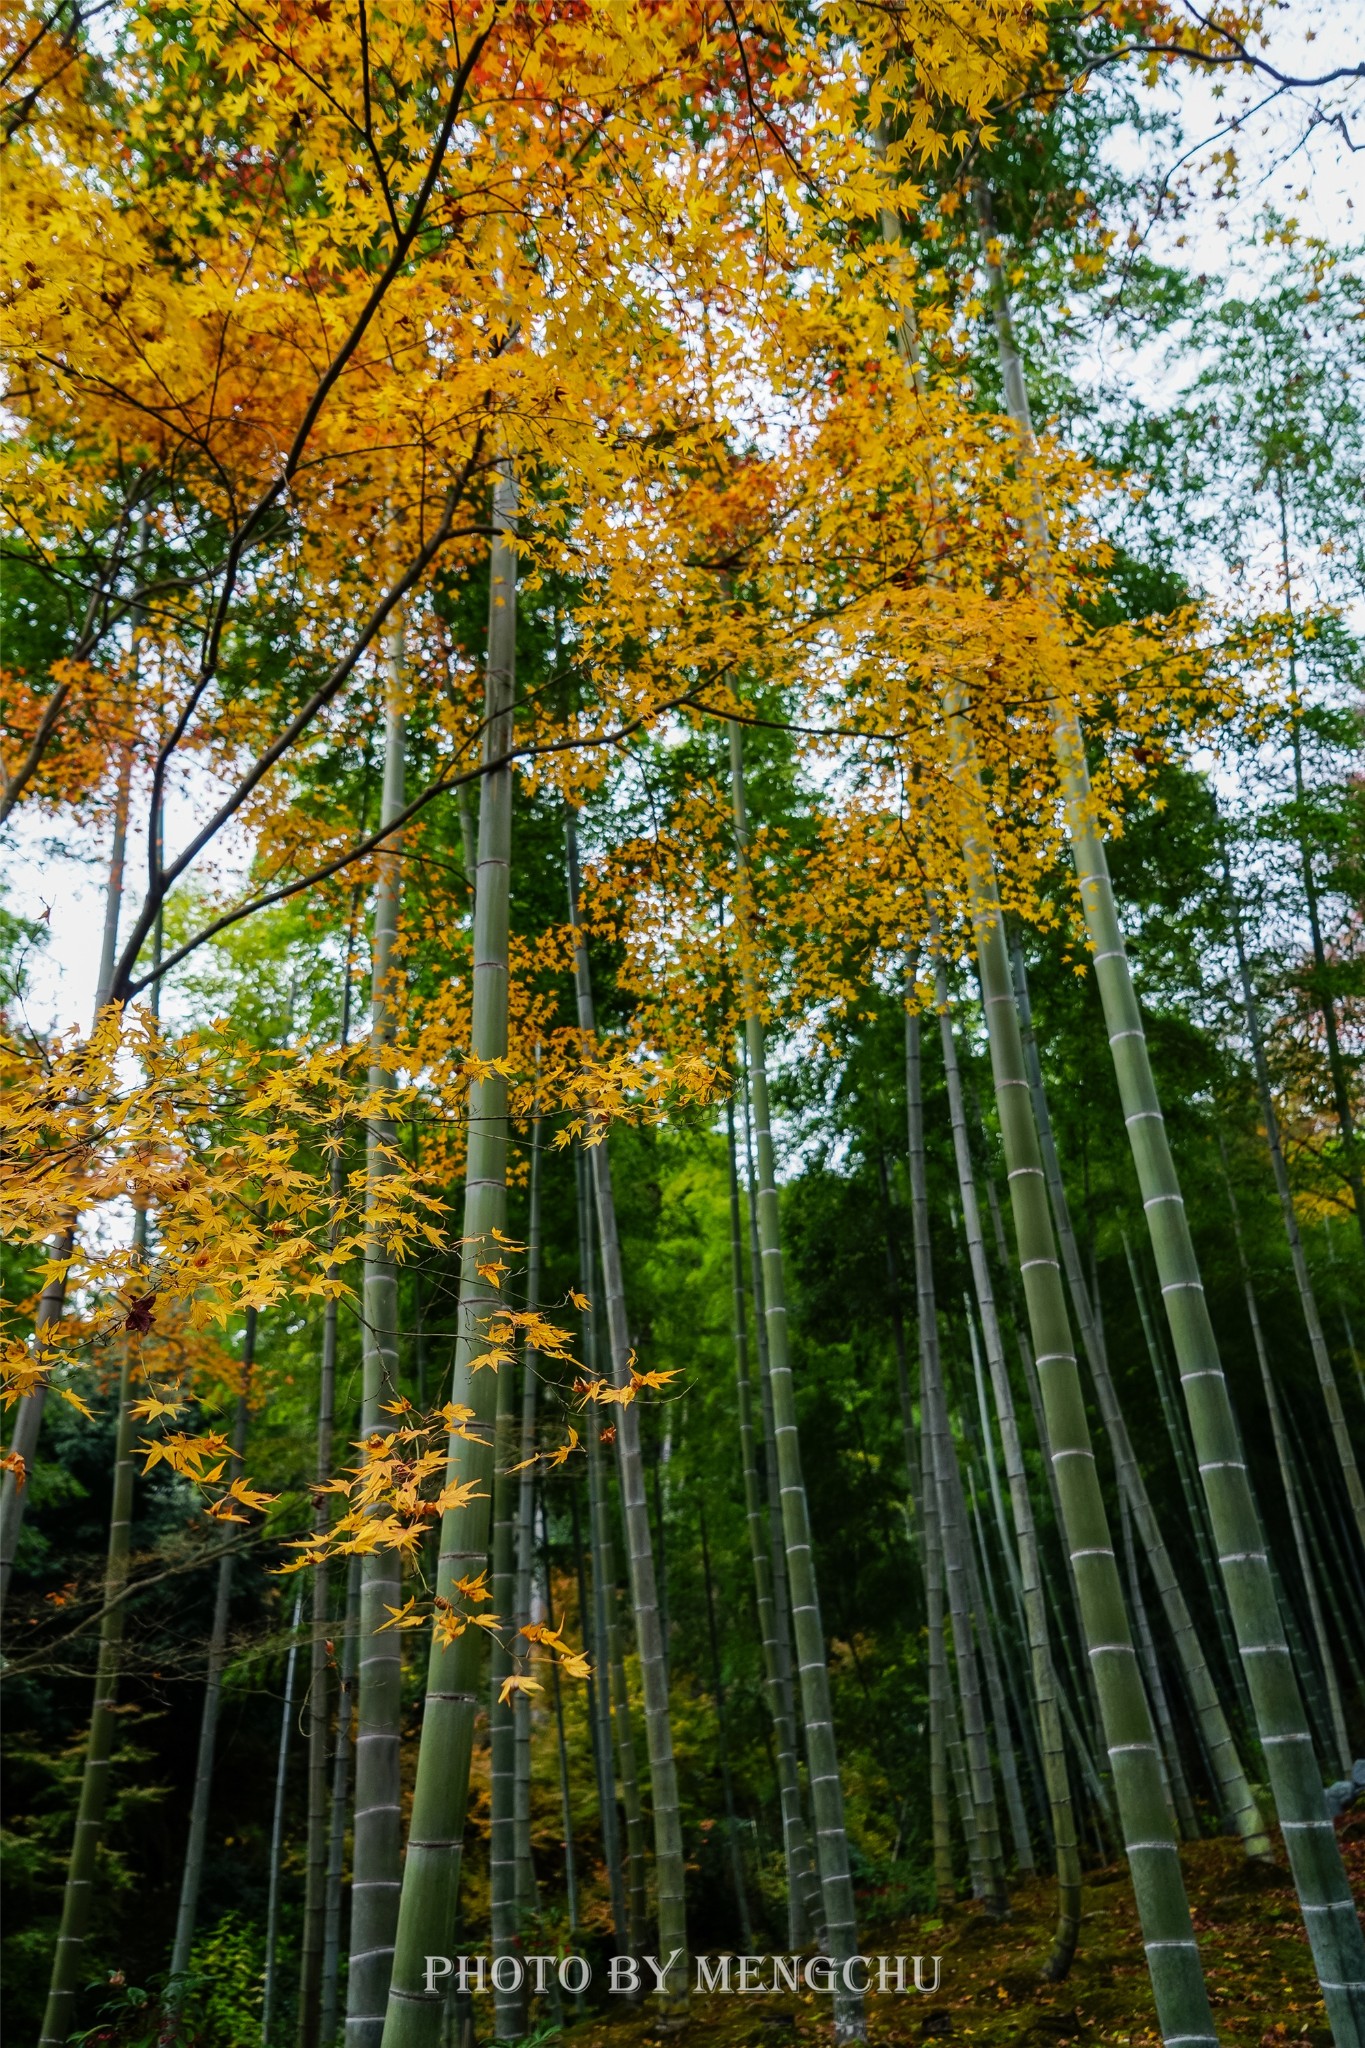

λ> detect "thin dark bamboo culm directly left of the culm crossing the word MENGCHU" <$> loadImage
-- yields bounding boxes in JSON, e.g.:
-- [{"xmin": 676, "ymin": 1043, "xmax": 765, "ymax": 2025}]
[{"xmin": 724, "ymin": 1098, "xmax": 817, "ymax": 1954}]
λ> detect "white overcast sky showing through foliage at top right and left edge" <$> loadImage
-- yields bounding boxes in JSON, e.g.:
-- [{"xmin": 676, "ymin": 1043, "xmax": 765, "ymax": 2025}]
[{"xmin": 0, "ymin": 0, "xmax": 1365, "ymax": 1030}]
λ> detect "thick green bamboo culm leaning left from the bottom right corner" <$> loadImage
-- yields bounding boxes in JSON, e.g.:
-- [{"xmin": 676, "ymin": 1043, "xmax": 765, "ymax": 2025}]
[{"xmin": 980, "ymin": 193, "xmax": 1365, "ymax": 2048}]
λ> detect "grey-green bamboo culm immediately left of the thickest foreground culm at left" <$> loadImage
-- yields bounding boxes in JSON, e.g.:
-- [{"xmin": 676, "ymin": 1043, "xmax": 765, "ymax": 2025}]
[{"xmin": 346, "ymin": 618, "xmax": 405, "ymax": 2048}]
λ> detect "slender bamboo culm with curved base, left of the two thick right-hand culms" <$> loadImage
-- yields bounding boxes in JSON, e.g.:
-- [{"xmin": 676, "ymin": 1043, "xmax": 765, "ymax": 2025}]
[{"xmin": 929, "ymin": 950, "xmax": 1081, "ymax": 1982}]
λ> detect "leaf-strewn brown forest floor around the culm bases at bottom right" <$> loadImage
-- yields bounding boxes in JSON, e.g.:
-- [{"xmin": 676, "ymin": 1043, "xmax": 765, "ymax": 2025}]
[{"xmin": 548, "ymin": 1808, "xmax": 1365, "ymax": 2048}]
